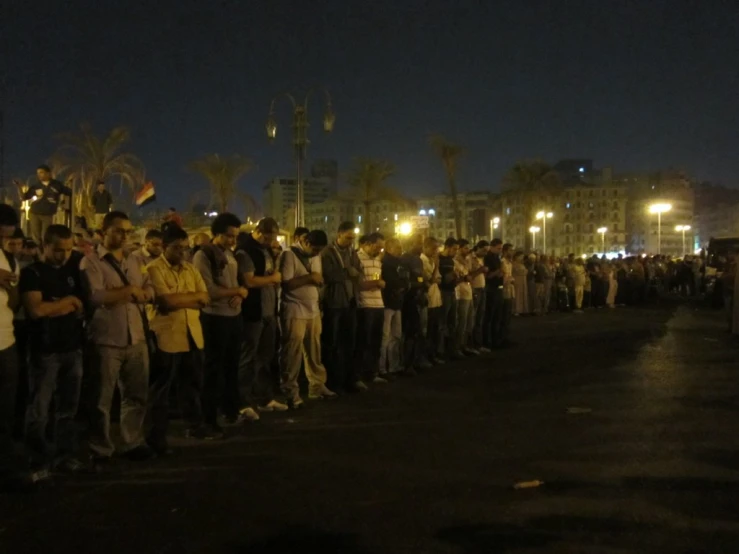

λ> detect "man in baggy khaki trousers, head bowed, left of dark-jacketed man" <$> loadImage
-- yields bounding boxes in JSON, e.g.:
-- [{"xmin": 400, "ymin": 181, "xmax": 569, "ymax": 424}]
[{"xmin": 280, "ymin": 231, "xmax": 336, "ymax": 409}]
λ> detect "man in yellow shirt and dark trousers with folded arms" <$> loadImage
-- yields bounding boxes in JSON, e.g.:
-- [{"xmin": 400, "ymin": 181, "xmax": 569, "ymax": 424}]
[{"xmin": 147, "ymin": 225, "xmax": 217, "ymax": 450}]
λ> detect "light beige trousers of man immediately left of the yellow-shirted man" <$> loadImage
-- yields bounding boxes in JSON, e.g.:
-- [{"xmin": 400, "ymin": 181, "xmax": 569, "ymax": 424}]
[{"xmin": 90, "ymin": 341, "xmax": 149, "ymax": 457}]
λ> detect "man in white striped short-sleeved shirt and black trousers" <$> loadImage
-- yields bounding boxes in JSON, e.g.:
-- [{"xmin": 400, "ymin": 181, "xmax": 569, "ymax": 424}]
[{"xmin": 357, "ymin": 233, "xmax": 388, "ymax": 384}]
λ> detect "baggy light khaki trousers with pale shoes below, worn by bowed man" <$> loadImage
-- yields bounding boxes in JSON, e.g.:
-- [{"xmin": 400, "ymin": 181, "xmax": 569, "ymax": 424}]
[{"xmin": 280, "ymin": 315, "xmax": 326, "ymax": 400}]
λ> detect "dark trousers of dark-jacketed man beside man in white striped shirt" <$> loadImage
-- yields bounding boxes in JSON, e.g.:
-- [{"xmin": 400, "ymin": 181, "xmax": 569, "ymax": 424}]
[{"xmin": 321, "ymin": 308, "xmax": 357, "ymax": 390}]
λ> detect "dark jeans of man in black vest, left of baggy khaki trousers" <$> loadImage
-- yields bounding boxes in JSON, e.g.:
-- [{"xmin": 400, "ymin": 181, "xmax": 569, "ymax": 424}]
[{"xmin": 239, "ymin": 317, "xmax": 277, "ymax": 409}]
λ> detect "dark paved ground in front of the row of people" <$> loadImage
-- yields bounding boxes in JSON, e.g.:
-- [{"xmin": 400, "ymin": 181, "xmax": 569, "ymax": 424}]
[{"xmin": 0, "ymin": 305, "xmax": 739, "ymax": 554}]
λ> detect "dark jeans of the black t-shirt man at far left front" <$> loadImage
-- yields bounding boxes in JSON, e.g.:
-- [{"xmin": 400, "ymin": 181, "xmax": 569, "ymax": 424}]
[{"xmin": 26, "ymin": 350, "xmax": 82, "ymax": 469}]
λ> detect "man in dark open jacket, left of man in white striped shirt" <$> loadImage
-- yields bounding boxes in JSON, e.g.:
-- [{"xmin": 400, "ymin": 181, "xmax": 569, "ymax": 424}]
[{"xmin": 321, "ymin": 221, "xmax": 367, "ymax": 392}]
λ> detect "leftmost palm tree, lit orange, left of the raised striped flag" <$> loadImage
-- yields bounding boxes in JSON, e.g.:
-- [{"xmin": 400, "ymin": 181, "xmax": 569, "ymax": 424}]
[{"xmin": 50, "ymin": 123, "xmax": 144, "ymax": 214}]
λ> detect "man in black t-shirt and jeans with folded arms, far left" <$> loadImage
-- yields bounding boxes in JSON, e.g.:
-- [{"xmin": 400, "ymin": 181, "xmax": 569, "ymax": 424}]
[{"xmin": 20, "ymin": 225, "xmax": 84, "ymax": 483}]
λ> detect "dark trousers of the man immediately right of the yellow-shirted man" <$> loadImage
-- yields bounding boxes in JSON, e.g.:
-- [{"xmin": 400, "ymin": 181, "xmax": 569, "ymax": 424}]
[{"xmin": 200, "ymin": 312, "xmax": 244, "ymax": 425}]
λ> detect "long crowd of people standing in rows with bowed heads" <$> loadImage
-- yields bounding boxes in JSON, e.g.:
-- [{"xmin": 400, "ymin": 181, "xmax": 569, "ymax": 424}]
[{"xmin": 0, "ymin": 183, "xmax": 694, "ymax": 485}]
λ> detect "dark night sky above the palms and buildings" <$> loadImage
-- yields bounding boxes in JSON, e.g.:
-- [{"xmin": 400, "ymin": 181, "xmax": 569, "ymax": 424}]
[{"xmin": 0, "ymin": 0, "xmax": 739, "ymax": 205}]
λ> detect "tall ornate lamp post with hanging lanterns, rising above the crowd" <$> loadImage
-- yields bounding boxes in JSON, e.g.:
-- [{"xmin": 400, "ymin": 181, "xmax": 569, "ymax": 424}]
[{"xmin": 265, "ymin": 87, "xmax": 336, "ymax": 227}]
